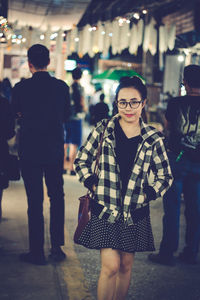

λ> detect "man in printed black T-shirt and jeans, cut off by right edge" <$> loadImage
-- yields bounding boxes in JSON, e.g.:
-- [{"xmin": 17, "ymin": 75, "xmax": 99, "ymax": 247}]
[{"xmin": 149, "ymin": 65, "xmax": 200, "ymax": 265}]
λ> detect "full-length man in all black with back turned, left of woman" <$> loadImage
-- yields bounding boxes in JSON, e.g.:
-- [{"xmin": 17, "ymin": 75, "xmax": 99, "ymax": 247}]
[{"xmin": 12, "ymin": 44, "xmax": 69, "ymax": 265}]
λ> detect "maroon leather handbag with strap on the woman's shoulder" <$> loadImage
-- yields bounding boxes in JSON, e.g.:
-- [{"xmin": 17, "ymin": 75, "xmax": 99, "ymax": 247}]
[{"xmin": 74, "ymin": 120, "xmax": 109, "ymax": 243}]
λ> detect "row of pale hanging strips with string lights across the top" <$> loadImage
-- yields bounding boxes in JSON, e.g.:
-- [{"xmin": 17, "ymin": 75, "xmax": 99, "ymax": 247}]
[{"xmin": 0, "ymin": 8, "xmax": 175, "ymax": 57}]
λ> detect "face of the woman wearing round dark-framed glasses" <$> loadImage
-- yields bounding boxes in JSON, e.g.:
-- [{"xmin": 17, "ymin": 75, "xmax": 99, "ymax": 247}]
[{"xmin": 117, "ymin": 87, "xmax": 145, "ymax": 123}]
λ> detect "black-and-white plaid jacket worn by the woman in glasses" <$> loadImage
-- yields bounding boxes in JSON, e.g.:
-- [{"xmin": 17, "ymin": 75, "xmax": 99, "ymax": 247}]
[{"xmin": 74, "ymin": 115, "xmax": 173, "ymax": 225}]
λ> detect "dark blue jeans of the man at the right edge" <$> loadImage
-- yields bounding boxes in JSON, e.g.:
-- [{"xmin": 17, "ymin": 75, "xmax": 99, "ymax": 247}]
[{"xmin": 160, "ymin": 152, "xmax": 200, "ymax": 259}]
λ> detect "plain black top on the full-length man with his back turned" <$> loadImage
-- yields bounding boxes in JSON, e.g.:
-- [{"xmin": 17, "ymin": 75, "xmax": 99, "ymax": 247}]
[{"xmin": 12, "ymin": 72, "xmax": 70, "ymax": 164}]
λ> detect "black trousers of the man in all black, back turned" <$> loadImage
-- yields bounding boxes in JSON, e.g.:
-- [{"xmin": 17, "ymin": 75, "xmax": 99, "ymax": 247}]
[{"xmin": 21, "ymin": 161, "xmax": 65, "ymax": 255}]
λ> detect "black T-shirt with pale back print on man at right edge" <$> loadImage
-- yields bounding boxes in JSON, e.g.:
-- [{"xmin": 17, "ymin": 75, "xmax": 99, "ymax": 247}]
[{"xmin": 165, "ymin": 96, "xmax": 200, "ymax": 162}]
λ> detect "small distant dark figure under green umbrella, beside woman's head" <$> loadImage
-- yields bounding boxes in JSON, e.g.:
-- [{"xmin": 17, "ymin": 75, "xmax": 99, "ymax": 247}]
[{"xmin": 93, "ymin": 93, "xmax": 109, "ymax": 124}]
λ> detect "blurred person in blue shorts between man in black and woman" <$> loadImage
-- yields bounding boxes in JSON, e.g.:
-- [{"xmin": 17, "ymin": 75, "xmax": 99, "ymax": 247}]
[{"xmin": 64, "ymin": 67, "xmax": 86, "ymax": 175}]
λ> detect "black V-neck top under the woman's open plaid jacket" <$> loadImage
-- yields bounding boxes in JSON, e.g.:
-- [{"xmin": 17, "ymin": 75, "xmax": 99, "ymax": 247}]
[{"xmin": 115, "ymin": 121, "xmax": 142, "ymax": 198}]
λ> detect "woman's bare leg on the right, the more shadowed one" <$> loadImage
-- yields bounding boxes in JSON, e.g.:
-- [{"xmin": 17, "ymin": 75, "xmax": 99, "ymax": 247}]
[{"xmin": 113, "ymin": 251, "xmax": 134, "ymax": 300}]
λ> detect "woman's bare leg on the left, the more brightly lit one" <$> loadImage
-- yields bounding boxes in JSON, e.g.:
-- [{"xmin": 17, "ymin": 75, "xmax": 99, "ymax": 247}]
[{"xmin": 97, "ymin": 248, "xmax": 120, "ymax": 300}]
